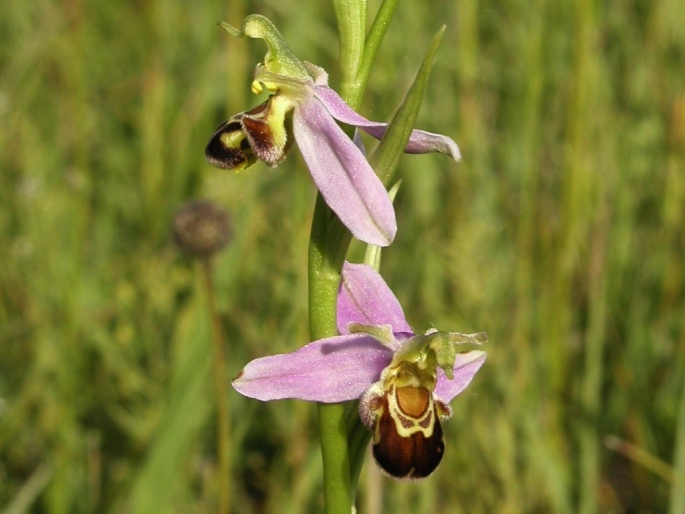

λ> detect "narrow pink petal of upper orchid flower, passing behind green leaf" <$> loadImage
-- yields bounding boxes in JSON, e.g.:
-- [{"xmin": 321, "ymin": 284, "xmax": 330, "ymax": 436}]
[{"xmin": 314, "ymin": 85, "xmax": 461, "ymax": 161}]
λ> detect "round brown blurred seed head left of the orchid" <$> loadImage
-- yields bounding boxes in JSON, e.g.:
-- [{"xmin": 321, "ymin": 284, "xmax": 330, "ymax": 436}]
[{"xmin": 171, "ymin": 200, "xmax": 232, "ymax": 259}]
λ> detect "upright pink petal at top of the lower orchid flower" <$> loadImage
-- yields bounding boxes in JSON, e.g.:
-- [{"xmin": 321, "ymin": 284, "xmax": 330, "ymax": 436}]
[{"xmin": 338, "ymin": 262, "xmax": 413, "ymax": 334}]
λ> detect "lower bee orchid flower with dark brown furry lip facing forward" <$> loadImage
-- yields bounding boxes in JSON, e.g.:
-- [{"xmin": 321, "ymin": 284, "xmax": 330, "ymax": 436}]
[{"xmin": 233, "ymin": 263, "xmax": 487, "ymax": 479}]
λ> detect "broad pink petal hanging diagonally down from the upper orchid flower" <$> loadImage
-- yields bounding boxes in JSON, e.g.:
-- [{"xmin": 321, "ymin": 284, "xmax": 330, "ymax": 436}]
[{"xmin": 293, "ymin": 97, "xmax": 397, "ymax": 246}]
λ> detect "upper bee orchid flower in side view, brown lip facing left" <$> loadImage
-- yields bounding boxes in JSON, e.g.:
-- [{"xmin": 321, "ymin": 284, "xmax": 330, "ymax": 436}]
[{"xmin": 205, "ymin": 15, "xmax": 461, "ymax": 246}]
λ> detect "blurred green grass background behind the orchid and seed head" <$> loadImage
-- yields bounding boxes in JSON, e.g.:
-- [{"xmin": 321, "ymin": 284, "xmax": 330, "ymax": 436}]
[{"xmin": 0, "ymin": 0, "xmax": 685, "ymax": 514}]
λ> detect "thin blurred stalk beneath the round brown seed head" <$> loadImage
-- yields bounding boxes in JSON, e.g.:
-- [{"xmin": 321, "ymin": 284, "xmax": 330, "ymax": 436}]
[{"xmin": 201, "ymin": 259, "xmax": 231, "ymax": 514}]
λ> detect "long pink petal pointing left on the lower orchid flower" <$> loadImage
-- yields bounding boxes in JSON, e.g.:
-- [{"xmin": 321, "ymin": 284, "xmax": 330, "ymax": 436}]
[{"xmin": 233, "ymin": 334, "xmax": 392, "ymax": 403}]
